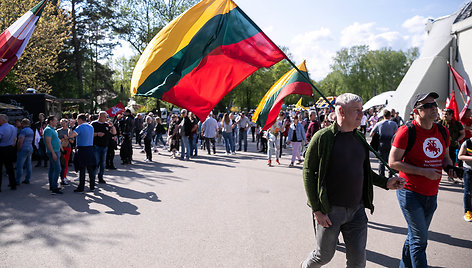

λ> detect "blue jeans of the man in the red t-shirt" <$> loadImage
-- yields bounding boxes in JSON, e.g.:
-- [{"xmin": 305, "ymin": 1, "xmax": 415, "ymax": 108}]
[{"xmin": 397, "ymin": 189, "xmax": 437, "ymax": 267}]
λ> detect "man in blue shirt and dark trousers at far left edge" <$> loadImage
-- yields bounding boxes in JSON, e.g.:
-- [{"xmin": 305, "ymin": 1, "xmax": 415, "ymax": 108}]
[{"xmin": 0, "ymin": 114, "xmax": 16, "ymax": 190}]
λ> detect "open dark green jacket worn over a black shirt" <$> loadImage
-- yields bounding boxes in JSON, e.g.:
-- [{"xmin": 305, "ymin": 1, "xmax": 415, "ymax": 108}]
[{"xmin": 303, "ymin": 123, "xmax": 388, "ymax": 214}]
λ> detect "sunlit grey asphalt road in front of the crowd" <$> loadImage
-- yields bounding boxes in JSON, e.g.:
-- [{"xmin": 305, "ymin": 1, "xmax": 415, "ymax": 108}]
[{"xmin": 0, "ymin": 139, "xmax": 472, "ymax": 267}]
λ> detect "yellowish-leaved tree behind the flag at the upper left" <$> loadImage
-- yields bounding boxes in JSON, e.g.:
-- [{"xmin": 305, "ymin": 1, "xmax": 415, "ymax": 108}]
[{"xmin": 0, "ymin": 0, "xmax": 70, "ymax": 93}]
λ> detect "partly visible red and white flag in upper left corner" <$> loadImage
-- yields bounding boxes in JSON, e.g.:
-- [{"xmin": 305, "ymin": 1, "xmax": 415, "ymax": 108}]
[{"xmin": 0, "ymin": 0, "xmax": 47, "ymax": 81}]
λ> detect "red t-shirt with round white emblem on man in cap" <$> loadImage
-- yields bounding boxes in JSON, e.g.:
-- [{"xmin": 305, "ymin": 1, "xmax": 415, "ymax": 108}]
[{"xmin": 392, "ymin": 121, "xmax": 450, "ymax": 196}]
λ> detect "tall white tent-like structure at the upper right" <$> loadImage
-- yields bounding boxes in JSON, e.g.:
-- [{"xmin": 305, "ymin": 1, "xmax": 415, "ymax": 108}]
[{"xmin": 386, "ymin": 2, "xmax": 472, "ymax": 118}]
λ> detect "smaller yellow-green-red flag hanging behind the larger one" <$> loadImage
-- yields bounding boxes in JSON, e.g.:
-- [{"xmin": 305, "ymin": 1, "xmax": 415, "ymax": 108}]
[{"xmin": 252, "ymin": 61, "xmax": 313, "ymax": 130}]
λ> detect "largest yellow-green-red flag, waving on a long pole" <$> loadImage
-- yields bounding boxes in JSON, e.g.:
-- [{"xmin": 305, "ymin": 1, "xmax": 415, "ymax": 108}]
[{"xmin": 131, "ymin": 0, "xmax": 286, "ymax": 119}]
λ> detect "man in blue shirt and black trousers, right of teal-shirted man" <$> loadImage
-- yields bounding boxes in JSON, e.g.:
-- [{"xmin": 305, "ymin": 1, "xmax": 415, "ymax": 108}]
[{"xmin": 69, "ymin": 114, "xmax": 97, "ymax": 192}]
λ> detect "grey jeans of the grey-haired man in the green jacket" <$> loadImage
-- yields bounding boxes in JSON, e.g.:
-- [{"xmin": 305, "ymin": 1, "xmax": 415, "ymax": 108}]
[{"xmin": 302, "ymin": 205, "xmax": 368, "ymax": 268}]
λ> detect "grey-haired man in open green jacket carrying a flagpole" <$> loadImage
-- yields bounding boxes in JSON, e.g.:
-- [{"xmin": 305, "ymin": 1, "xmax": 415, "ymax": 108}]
[{"xmin": 301, "ymin": 93, "xmax": 403, "ymax": 268}]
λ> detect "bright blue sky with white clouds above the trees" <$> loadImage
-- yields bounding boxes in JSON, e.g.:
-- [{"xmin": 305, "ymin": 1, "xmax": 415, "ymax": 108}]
[{"xmin": 113, "ymin": 0, "xmax": 470, "ymax": 81}]
